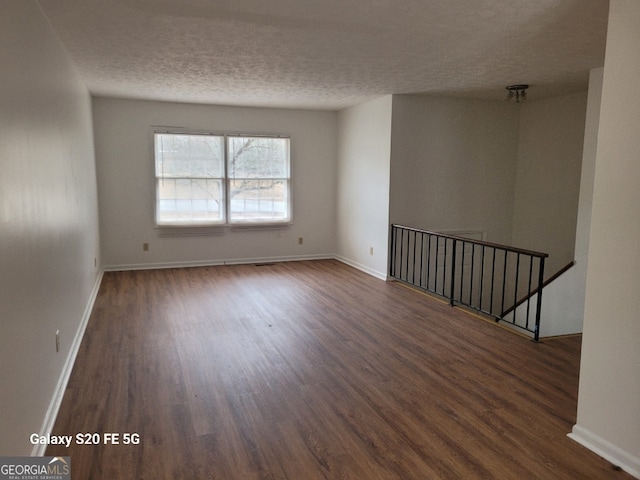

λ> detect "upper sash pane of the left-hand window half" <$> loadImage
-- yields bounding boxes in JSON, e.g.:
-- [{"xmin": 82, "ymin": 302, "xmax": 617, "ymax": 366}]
[{"xmin": 155, "ymin": 133, "xmax": 224, "ymax": 178}]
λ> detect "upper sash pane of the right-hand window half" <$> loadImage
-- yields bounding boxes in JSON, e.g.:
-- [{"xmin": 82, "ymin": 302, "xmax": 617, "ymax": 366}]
[{"xmin": 229, "ymin": 137, "xmax": 289, "ymax": 178}]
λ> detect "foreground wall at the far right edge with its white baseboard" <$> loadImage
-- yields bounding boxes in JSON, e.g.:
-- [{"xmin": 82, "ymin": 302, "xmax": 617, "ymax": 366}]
[{"xmin": 571, "ymin": 0, "xmax": 640, "ymax": 478}]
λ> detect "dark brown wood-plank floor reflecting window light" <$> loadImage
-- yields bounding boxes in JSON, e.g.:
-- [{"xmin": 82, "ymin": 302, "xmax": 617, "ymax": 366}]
[{"xmin": 47, "ymin": 261, "xmax": 631, "ymax": 480}]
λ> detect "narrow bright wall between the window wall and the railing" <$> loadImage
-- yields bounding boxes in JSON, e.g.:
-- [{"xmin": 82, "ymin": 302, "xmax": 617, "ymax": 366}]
[{"xmin": 337, "ymin": 96, "xmax": 392, "ymax": 278}]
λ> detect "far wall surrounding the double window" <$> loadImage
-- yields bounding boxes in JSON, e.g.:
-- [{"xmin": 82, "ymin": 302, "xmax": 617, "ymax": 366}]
[{"xmin": 93, "ymin": 98, "xmax": 337, "ymax": 268}]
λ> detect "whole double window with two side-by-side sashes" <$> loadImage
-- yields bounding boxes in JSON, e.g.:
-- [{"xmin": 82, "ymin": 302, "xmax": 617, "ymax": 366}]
[{"xmin": 154, "ymin": 133, "xmax": 291, "ymax": 226}]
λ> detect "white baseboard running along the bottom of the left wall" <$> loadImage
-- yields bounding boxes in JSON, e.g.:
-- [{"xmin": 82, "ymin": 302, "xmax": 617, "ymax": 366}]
[{"xmin": 31, "ymin": 270, "xmax": 104, "ymax": 457}]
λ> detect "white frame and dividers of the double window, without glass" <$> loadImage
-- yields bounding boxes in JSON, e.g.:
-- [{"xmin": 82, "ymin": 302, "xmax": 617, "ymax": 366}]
[{"xmin": 152, "ymin": 129, "xmax": 293, "ymax": 230}]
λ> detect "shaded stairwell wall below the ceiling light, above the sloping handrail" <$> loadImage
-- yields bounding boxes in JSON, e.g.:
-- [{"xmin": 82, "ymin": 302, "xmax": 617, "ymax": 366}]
[{"xmin": 511, "ymin": 92, "xmax": 587, "ymax": 277}]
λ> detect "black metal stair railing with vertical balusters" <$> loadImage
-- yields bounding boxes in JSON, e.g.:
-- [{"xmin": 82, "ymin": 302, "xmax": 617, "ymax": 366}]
[{"xmin": 389, "ymin": 225, "xmax": 548, "ymax": 341}]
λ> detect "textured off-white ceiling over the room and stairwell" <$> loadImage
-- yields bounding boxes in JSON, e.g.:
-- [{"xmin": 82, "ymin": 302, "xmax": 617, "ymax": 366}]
[{"xmin": 39, "ymin": 0, "xmax": 608, "ymax": 109}]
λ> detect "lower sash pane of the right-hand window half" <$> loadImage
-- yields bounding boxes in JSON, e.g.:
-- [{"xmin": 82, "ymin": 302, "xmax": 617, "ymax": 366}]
[{"xmin": 229, "ymin": 179, "xmax": 289, "ymax": 222}]
